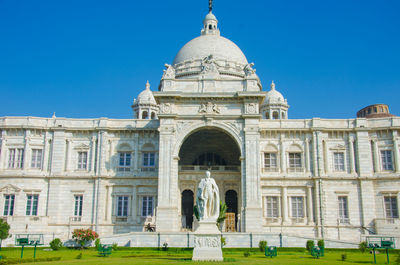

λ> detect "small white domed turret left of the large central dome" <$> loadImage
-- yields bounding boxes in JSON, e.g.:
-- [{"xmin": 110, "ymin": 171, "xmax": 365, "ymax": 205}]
[{"xmin": 132, "ymin": 81, "xmax": 158, "ymax": 120}]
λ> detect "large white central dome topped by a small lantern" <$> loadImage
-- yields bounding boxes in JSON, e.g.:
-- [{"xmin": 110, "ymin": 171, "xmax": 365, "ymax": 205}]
[{"xmin": 173, "ymin": 13, "xmax": 247, "ymax": 65}]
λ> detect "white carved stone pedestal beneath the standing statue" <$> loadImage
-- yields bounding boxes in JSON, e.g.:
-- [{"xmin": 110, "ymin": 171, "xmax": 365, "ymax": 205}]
[{"xmin": 192, "ymin": 221, "xmax": 224, "ymax": 261}]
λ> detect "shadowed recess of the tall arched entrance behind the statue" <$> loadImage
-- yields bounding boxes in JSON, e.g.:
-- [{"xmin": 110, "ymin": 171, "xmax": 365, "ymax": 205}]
[{"xmin": 178, "ymin": 127, "xmax": 241, "ymax": 229}]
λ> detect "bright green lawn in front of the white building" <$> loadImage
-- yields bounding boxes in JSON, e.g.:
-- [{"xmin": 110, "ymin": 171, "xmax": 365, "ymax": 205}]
[{"xmin": 0, "ymin": 247, "xmax": 399, "ymax": 265}]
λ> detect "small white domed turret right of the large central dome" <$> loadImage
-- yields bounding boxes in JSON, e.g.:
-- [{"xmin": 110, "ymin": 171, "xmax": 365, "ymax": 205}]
[{"xmin": 261, "ymin": 81, "xmax": 289, "ymax": 120}]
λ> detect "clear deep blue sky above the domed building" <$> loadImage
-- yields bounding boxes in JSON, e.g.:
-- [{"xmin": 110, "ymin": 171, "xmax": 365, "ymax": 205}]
[{"xmin": 0, "ymin": 0, "xmax": 400, "ymax": 118}]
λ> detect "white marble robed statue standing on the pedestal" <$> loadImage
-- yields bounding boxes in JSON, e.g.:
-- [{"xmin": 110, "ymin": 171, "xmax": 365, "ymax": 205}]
[{"xmin": 196, "ymin": 170, "xmax": 219, "ymax": 221}]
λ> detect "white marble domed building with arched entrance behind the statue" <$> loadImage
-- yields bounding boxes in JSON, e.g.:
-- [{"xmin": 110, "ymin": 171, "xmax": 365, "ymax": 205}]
[{"xmin": 0, "ymin": 9, "xmax": 400, "ymax": 245}]
